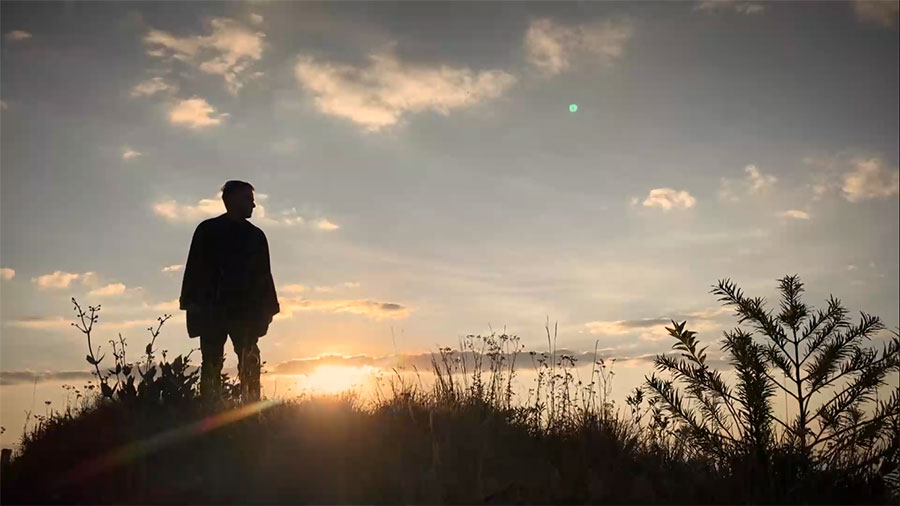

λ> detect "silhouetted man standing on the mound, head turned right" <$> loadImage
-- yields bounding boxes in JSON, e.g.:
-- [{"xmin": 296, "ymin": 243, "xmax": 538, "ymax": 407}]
[{"xmin": 179, "ymin": 181, "xmax": 280, "ymax": 401}]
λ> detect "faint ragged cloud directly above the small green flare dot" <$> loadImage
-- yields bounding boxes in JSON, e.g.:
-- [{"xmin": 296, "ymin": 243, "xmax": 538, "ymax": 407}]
[{"xmin": 525, "ymin": 19, "xmax": 632, "ymax": 76}]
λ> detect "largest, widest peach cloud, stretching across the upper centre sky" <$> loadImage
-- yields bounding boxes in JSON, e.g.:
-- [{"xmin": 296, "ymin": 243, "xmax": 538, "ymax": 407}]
[{"xmin": 294, "ymin": 45, "xmax": 516, "ymax": 132}]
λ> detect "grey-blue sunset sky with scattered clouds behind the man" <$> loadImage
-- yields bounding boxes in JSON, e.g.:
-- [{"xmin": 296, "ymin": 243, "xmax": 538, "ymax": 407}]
[{"xmin": 0, "ymin": 1, "xmax": 900, "ymax": 442}]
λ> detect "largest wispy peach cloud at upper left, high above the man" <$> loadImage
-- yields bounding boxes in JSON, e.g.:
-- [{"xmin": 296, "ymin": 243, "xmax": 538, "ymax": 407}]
[{"xmin": 144, "ymin": 18, "xmax": 266, "ymax": 95}]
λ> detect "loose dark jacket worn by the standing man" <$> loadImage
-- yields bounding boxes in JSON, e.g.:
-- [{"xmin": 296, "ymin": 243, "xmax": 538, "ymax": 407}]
[{"xmin": 179, "ymin": 214, "xmax": 280, "ymax": 337}]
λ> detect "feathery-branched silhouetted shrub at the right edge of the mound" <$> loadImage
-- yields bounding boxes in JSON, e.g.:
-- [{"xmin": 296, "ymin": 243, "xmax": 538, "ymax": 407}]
[{"xmin": 646, "ymin": 276, "xmax": 900, "ymax": 496}]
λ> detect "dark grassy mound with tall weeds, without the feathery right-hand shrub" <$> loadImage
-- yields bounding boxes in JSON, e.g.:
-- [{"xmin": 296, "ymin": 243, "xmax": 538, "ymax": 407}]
[{"xmin": 0, "ymin": 300, "xmax": 893, "ymax": 504}]
